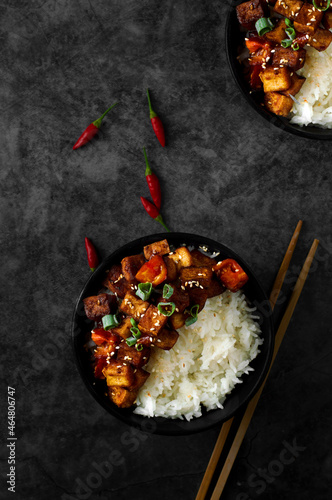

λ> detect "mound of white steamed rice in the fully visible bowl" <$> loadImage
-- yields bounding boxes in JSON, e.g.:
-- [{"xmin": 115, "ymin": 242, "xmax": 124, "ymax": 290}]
[{"xmin": 135, "ymin": 291, "xmax": 263, "ymax": 420}]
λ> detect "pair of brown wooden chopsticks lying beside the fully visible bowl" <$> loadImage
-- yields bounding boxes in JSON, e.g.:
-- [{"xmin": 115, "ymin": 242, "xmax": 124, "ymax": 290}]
[{"xmin": 196, "ymin": 220, "xmax": 319, "ymax": 500}]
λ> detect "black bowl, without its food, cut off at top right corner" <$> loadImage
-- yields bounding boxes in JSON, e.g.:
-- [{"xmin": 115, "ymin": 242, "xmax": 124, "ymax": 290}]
[{"xmin": 225, "ymin": 0, "xmax": 332, "ymax": 140}]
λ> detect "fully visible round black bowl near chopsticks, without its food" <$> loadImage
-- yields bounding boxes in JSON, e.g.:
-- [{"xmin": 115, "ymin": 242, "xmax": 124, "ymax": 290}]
[{"xmin": 72, "ymin": 233, "xmax": 274, "ymax": 435}]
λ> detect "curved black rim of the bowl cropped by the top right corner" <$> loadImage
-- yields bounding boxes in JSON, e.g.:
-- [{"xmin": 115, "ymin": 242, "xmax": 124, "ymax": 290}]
[{"xmin": 225, "ymin": 0, "xmax": 332, "ymax": 141}]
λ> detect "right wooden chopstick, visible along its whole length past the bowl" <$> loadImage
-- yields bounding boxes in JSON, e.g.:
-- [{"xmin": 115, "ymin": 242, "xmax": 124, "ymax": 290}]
[{"xmin": 211, "ymin": 240, "xmax": 319, "ymax": 500}]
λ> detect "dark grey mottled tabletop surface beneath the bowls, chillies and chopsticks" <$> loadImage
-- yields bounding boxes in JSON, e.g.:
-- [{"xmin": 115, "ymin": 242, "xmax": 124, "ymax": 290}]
[{"xmin": 0, "ymin": 0, "xmax": 332, "ymax": 500}]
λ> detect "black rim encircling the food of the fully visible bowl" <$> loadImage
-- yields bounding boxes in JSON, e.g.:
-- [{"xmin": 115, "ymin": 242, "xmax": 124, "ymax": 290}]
[{"xmin": 71, "ymin": 233, "xmax": 274, "ymax": 435}]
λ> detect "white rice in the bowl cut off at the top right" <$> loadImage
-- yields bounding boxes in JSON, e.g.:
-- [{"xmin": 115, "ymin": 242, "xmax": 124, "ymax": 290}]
[{"xmin": 291, "ymin": 40, "xmax": 332, "ymax": 128}]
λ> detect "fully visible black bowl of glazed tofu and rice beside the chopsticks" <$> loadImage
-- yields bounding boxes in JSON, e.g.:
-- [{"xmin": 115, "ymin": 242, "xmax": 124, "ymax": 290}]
[{"xmin": 72, "ymin": 233, "xmax": 274, "ymax": 435}]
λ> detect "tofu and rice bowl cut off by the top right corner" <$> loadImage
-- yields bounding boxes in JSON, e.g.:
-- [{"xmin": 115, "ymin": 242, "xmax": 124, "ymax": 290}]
[{"xmin": 225, "ymin": 0, "xmax": 332, "ymax": 140}]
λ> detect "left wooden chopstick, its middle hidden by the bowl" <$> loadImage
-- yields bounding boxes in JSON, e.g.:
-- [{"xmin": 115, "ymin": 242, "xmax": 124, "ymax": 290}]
[{"xmin": 196, "ymin": 220, "xmax": 302, "ymax": 500}]
